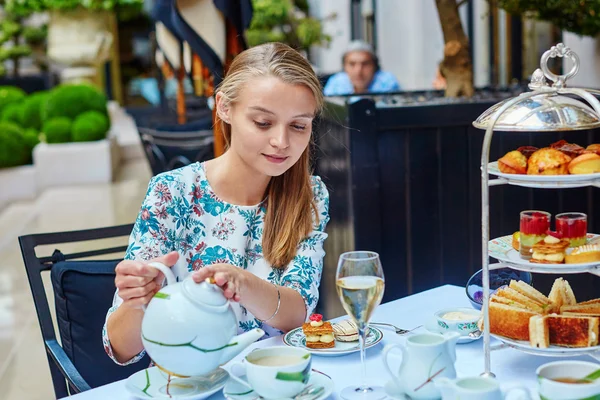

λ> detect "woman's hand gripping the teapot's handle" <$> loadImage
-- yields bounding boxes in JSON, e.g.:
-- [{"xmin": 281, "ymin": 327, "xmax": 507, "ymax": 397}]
[{"xmin": 115, "ymin": 251, "xmax": 179, "ymax": 308}]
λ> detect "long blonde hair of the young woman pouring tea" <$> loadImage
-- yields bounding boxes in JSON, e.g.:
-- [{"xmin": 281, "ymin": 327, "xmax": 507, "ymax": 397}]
[{"xmin": 215, "ymin": 43, "xmax": 324, "ymax": 268}]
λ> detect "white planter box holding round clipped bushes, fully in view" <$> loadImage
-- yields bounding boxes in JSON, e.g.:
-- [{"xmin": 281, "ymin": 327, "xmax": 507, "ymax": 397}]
[{"xmin": 33, "ymin": 136, "xmax": 121, "ymax": 189}]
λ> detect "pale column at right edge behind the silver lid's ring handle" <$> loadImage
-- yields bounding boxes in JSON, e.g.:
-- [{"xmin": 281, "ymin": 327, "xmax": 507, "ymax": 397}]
[{"xmin": 564, "ymin": 31, "xmax": 600, "ymax": 89}]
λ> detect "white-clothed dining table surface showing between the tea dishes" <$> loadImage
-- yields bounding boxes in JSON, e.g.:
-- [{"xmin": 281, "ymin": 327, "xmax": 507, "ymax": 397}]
[{"xmin": 64, "ymin": 282, "xmax": 593, "ymax": 400}]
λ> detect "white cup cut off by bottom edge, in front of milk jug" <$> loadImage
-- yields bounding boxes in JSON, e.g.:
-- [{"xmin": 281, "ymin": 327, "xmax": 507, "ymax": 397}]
[{"xmin": 434, "ymin": 376, "xmax": 531, "ymax": 400}]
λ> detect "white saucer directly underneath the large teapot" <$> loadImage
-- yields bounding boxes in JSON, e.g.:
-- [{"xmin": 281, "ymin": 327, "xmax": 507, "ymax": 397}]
[{"xmin": 125, "ymin": 367, "xmax": 229, "ymax": 400}]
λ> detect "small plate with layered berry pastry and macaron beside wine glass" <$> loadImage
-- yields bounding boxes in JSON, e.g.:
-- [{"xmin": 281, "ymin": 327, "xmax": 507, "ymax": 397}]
[{"xmin": 283, "ymin": 314, "xmax": 383, "ymax": 356}]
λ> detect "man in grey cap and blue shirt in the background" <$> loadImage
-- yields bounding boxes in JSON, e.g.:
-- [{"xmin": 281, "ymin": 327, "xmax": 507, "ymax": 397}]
[{"xmin": 323, "ymin": 40, "xmax": 400, "ymax": 96}]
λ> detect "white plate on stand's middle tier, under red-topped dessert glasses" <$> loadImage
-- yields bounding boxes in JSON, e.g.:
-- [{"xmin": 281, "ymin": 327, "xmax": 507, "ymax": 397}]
[{"xmin": 488, "ymin": 233, "xmax": 600, "ymax": 273}]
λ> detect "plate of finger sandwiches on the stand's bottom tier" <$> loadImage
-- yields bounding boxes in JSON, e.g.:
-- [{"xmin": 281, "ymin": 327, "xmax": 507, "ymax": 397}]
[{"xmin": 489, "ymin": 278, "xmax": 600, "ymax": 357}]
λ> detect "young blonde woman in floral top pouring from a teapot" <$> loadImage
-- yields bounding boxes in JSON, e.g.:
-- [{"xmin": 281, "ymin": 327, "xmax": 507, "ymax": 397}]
[{"xmin": 103, "ymin": 43, "xmax": 329, "ymax": 365}]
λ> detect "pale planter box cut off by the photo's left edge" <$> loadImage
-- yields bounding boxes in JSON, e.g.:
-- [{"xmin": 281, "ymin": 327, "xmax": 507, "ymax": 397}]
[{"xmin": 0, "ymin": 165, "xmax": 37, "ymax": 209}]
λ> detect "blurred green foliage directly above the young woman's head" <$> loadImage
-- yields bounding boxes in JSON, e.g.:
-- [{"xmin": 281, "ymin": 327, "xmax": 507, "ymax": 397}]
[{"xmin": 246, "ymin": 0, "xmax": 331, "ymax": 50}]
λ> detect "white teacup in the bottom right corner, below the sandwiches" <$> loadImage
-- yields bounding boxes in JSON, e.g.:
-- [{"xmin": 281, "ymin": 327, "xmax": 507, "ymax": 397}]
[{"xmin": 536, "ymin": 361, "xmax": 600, "ymax": 400}]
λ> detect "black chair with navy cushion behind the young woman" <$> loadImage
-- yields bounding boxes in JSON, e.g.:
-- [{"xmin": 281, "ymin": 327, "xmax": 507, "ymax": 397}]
[{"xmin": 19, "ymin": 224, "xmax": 150, "ymax": 398}]
